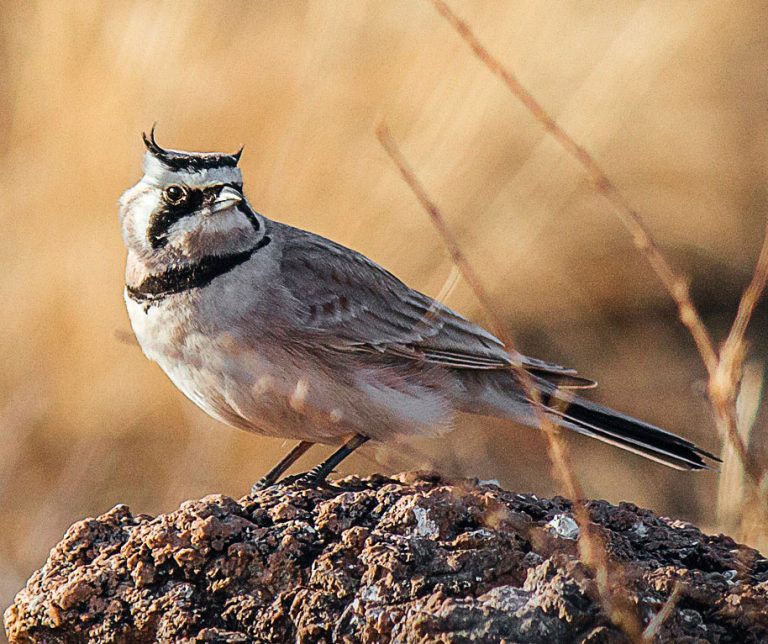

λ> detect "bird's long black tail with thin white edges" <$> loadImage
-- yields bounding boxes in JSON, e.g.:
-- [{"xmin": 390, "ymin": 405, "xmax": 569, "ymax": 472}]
[{"xmin": 544, "ymin": 394, "xmax": 720, "ymax": 470}]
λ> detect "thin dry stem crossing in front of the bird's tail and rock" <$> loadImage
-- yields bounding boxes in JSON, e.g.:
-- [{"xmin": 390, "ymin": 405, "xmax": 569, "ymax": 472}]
[{"xmin": 376, "ymin": 123, "xmax": 642, "ymax": 641}]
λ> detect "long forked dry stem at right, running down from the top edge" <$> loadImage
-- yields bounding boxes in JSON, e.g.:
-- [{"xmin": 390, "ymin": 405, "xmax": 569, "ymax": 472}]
[{"xmin": 430, "ymin": 0, "xmax": 768, "ymax": 524}]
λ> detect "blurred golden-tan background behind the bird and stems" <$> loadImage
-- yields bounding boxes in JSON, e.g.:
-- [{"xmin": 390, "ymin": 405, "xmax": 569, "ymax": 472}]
[{"xmin": 0, "ymin": 0, "xmax": 768, "ymax": 608}]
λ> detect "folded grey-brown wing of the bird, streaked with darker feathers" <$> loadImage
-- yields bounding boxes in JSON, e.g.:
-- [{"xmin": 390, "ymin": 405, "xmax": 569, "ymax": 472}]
[{"xmin": 281, "ymin": 225, "xmax": 593, "ymax": 387}]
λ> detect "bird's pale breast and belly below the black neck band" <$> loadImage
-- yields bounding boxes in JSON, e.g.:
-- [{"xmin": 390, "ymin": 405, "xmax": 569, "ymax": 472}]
[{"xmin": 125, "ymin": 256, "xmax": 450, "ymax": 443}]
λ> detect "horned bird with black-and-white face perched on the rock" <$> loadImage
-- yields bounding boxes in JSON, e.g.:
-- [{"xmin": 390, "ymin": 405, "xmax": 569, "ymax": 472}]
[{"xmin": 119, "ymin": 126, "xmax": 719, "ymax": 489}]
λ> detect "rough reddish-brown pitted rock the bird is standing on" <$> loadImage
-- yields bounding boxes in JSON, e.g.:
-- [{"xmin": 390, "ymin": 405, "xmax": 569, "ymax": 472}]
[{"xmin": 5, "ymin": 474, "xmax": 768, "ymax": 643}]
